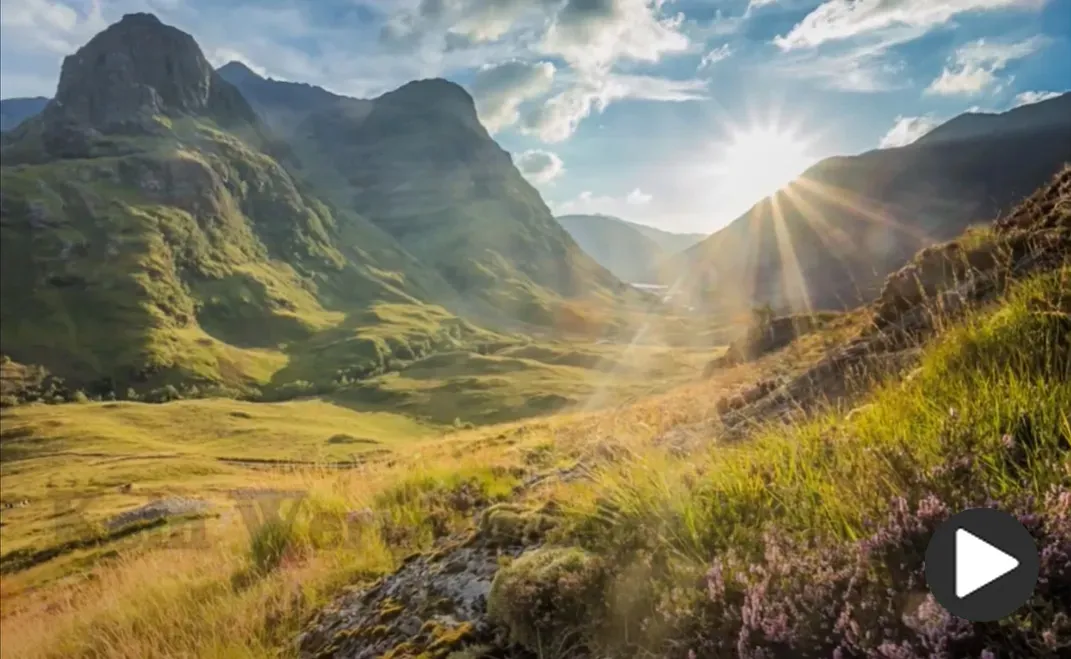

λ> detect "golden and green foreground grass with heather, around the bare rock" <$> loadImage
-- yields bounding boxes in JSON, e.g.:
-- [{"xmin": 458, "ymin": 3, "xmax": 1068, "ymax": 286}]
[{"xmin": 2, "ymin": 268, "xmax": 1071, "ymax": 657}]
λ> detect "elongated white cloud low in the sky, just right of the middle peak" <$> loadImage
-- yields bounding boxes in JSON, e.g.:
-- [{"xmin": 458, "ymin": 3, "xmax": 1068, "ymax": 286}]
[{"xmin": 522, "ymin": 74, "xmax": 707, "ymax": 143}]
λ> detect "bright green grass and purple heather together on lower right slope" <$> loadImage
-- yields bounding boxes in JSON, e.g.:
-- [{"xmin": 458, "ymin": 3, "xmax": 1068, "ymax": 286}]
[{"xmin": 529, "ymin": 267, "xmax": 1071, "ymax": 659}]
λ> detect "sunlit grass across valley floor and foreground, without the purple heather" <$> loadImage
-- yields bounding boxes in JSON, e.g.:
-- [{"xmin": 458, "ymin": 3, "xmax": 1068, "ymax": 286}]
[{"xmin": 3, "ymin": 268, "xmax": 1071, "ymax": 657}]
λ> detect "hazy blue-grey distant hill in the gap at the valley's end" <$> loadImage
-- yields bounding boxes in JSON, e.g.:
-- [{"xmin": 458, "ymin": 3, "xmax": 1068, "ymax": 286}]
[{"xmin": 558, "ymin": 215, "xmax": 704, "ymax": 283}]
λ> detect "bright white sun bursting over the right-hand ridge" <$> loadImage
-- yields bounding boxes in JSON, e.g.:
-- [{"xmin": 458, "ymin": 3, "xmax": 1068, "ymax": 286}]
[{"xmin": 714, "ymin": 126, "xmax": 816, "ymax": 203}]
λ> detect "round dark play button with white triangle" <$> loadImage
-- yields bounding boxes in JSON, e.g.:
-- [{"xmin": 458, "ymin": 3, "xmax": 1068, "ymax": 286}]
[{"xmin": 926, "ymin": 508, "xmax": 1038, "ymax": 621}]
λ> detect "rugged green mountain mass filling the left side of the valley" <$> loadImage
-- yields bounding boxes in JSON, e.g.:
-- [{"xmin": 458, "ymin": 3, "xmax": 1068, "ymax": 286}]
[{"xmin": 0, "ymin": 14, "xmax": 627, "ymax": 394}]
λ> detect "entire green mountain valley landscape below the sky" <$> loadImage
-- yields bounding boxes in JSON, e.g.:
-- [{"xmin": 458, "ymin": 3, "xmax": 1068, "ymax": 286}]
[{"xmin": 0, "ymin": 9, "xmax": 1071, "ymax": 659}]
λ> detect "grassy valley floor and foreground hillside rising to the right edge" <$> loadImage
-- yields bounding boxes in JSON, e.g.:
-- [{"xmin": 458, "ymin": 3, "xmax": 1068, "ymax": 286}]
[{"xmin": 0, "ymin": 169, "xmax": 1071, "ymax": 659}]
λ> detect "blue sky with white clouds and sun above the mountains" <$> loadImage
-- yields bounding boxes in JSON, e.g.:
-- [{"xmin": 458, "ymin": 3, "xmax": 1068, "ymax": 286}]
[{"xmin": 0, "ymin": 0, "xmax": 1071, "ymax": 233}]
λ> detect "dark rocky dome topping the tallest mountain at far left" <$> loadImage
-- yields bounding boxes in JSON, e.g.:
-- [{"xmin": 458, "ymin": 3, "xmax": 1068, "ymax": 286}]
[{"xmin": 52, "ymin": 14, "xmax": 253, "ymax": 132}]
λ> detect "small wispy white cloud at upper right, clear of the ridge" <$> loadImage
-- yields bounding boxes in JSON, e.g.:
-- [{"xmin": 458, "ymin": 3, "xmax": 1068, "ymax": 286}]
[{"xmin": 926, "ymin": 36, "xmax": 1045, "ymax": 95}]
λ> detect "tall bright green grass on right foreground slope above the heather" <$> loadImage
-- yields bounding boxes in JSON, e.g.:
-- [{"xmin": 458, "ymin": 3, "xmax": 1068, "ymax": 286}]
[{"xmin": 517, "ymin": 268, "xmax": 1071, "ymax": 651}]
